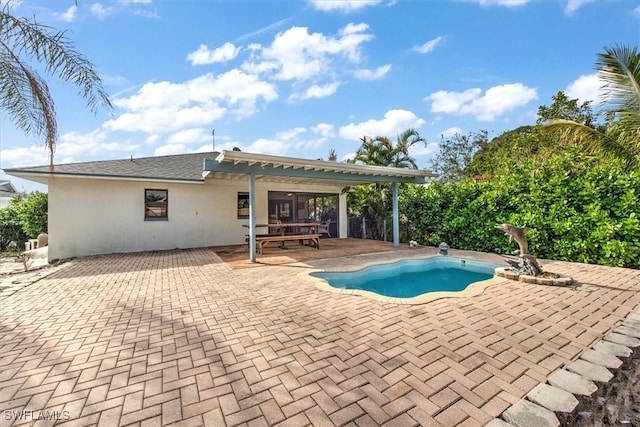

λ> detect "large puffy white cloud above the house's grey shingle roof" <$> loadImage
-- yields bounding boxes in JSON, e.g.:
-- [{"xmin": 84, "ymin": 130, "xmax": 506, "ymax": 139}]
[{"xmin": 104, "ymin": 69, "xmax": 278, "ymax": 133}]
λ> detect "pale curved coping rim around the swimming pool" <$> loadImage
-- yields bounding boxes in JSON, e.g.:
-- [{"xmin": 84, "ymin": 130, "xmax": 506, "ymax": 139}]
[{"xmin": 298, "ymin": 251, "xmax": 509, "ymax": 305}]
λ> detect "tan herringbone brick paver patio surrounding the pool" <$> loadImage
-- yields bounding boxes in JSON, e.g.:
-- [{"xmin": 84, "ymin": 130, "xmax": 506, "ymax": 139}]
[{"xmin": 0, "ymin": 249, "xmax": 640, "ymax": 426}]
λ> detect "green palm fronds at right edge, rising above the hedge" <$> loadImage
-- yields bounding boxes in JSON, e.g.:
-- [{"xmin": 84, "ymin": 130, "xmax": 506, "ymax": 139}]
[{"xmin": 546, "ymin": 46, "xmax": 640, "ymax": 169}]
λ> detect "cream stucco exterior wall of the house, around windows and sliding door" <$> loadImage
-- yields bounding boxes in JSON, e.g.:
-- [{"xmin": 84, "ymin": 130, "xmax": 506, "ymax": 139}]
[{"xmin": 49, "ymin": 177, "xmax": 347, "ymax": 260}]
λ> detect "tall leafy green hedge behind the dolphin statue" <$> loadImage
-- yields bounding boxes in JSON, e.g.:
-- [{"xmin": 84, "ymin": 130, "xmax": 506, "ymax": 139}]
[{"xmin": 400, "ymin": 155, "xmax": 640, "ymax": 268}]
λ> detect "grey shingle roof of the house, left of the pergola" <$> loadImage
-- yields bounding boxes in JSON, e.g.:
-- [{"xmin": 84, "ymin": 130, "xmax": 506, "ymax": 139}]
[{"xmin": 5, "ymin": 152, "xmax": 219, "ymax": 181}]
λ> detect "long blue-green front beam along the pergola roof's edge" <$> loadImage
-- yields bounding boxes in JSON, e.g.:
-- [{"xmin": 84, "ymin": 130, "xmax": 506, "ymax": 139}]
[{"xmin": 204, "ymin": 159, "xmax": 427, "ymax": 184}]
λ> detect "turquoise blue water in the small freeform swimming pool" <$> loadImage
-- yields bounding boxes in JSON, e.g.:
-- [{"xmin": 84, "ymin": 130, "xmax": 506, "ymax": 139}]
[{"xmin": 311, "ymin": 257, "xmax": 497, "ymax": 298}]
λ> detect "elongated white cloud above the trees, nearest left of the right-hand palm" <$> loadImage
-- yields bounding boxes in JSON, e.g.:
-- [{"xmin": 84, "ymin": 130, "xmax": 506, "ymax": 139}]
[{"xmin": 425, "ymin": 83, "xmax": 538, "ymax": 121}]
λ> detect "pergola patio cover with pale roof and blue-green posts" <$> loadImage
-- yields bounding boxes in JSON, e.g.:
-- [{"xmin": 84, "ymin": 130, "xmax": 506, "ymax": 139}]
[{"xmin": 204, "ymin": 150, "xmax": 436, "ymax": 262}]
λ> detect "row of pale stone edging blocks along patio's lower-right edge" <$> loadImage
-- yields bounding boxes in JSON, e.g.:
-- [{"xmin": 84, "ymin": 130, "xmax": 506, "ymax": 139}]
[{"xmin": 485, "ymin": 311, "xmax": 640, "ymax": 427}]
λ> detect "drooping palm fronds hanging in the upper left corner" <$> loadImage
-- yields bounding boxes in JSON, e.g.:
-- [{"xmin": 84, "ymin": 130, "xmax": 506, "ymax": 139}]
[{"xmin": 0, "ymin": 5, "xmax": 112, "ymax": 170}]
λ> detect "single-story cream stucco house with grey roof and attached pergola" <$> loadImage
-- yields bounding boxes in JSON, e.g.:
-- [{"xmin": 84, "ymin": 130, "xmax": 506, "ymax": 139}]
[{"xmin": 5, "ymin": 151, "xmax": 433, "ymax": 261}]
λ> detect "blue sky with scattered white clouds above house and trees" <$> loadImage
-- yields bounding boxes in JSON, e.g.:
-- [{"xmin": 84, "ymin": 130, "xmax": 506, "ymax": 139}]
[{"xmin": 0, "ymin": 0, "xmax": 640, "ymax": 191}]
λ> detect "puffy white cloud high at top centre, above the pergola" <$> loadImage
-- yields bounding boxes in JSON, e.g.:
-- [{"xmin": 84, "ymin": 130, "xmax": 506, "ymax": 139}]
[{"xmin": 243, "ymin": 23, "xmax": 373, "ymax": 81}]
